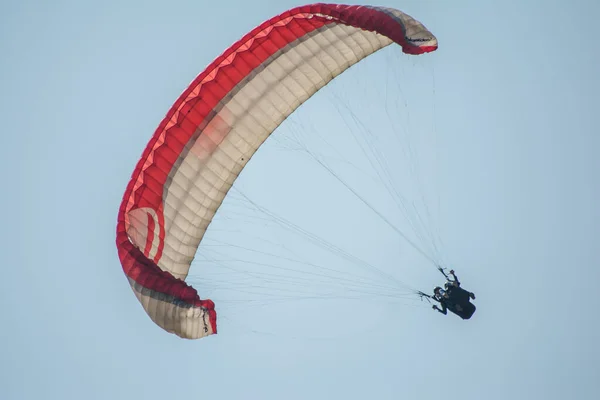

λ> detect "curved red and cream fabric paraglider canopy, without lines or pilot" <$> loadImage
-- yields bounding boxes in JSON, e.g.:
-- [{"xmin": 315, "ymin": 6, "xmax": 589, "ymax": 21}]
[{"xmin": 116, "ymin": 4, "xmax": 438, "ymax": 339}]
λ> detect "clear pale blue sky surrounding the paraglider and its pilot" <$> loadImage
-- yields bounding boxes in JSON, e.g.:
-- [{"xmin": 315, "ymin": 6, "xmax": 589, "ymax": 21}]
[{"xmin": 0, "ymin": 0, "xmax": 600, "ymax": 400}]
